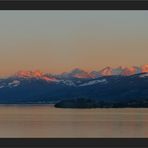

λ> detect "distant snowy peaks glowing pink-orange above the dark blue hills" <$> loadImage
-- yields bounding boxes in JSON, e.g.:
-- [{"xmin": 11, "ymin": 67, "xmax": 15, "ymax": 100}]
[{"xmin": 5, "ymin": 64, "xmax": 148, "ymax": 81}]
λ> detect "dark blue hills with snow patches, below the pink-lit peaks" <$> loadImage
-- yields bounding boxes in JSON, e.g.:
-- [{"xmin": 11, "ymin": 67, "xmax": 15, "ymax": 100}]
[{"xmin": 0, "ymin": 73, "xmax": 148, "ymax": 104}]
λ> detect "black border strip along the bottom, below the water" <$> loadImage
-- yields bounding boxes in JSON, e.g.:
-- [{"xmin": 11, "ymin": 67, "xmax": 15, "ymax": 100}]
[{"xmin": 0, "ymin": 138, "xmax": 148, "ymax": 148}]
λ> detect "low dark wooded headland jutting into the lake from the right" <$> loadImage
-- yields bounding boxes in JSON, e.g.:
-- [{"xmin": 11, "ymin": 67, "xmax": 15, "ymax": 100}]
[{"xmin": 55, "ymin": 98, "xmax": 148, "ymax": 108}]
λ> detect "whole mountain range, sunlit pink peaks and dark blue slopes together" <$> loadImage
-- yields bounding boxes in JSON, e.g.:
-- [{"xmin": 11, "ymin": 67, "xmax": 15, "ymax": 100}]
[{"xmin": 0, "ymin": 65, "xmax": 148, "ymax": 104}]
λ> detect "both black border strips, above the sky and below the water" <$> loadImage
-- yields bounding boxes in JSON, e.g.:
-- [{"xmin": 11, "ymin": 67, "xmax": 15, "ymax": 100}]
[{"xmin": 0, "ymin": 0, "xmax": 148, "ymax": 148}]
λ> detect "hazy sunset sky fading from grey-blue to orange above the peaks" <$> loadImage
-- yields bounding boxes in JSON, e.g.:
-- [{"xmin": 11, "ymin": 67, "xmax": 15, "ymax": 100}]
[{"xmin": 0, "ymin": 10, "xmax": 148, "ymax": 75}]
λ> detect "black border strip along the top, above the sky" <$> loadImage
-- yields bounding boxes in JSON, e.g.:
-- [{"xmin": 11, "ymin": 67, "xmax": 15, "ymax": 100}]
[{"xmin": 0, "ymin": 0, "xmax": 148, "ymax": 10}]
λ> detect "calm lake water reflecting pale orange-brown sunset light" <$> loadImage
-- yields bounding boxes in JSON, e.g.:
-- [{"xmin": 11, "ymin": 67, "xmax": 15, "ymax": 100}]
[{"xmin": 0, "ymin": 105, "xmax": 148, "ymax": 138}]
